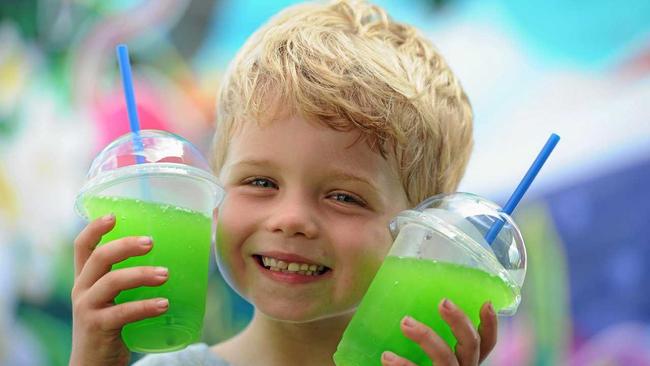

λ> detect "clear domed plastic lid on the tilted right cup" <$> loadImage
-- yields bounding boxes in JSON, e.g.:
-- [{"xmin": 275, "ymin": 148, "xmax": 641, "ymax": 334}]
[{"xmin": 390, "ymin": 193, "xmax": 526, "ymax": 288}]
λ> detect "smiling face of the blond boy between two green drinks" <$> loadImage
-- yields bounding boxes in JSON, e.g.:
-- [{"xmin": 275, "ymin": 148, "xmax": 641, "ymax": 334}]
[{"xmin": 217, "ymin": 117, "xmax": 407, "ymax": 322}]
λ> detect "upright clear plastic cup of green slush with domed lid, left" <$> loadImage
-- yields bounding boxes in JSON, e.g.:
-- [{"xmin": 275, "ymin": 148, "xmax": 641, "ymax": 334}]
[{"xmin": 75, "ymin": 130, "xmax": 224, "ymax": 352}]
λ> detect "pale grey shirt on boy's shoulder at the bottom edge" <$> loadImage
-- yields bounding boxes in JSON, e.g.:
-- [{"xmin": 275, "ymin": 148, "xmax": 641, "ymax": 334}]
[{"xmin": 133, "ymin": 343, "xmax": 229, "ymax": 366}]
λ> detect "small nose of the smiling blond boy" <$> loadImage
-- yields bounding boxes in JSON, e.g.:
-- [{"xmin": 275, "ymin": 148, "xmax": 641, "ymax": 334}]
[{"xmin": 266, "ymin": 193, "xmax": 319, "ymax": 239}]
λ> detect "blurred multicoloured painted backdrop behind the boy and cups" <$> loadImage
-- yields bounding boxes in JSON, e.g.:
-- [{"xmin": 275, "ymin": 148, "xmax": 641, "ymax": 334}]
[{"xmin": 0, "ymin": 0, "xmax": 650, "ymax": 366}]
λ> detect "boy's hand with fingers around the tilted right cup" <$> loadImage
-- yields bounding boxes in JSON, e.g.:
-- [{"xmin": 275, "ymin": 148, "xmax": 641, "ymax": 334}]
[{"xmin": 381, "ymin": 300, "xmax": 497, "ymax": 366}]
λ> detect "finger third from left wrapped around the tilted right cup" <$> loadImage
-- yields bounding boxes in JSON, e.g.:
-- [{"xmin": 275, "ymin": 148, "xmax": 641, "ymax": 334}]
[{"xmin": 438, "ymin": 299, "xmax": 481, "ymax": 365}]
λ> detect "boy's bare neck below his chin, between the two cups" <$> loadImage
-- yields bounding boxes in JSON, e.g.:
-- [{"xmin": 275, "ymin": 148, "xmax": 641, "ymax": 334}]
[{"xmin": 212, "ymin": 311, "xmax": 353, "ymax": 366}]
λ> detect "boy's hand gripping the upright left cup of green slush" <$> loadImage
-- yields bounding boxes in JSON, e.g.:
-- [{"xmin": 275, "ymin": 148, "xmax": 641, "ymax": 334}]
[{"xmin": 70, "ymin": 215, "xmax": 168, "ymax": 365}]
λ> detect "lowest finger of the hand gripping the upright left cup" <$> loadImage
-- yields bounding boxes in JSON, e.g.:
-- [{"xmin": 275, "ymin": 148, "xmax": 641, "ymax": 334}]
[{"xmin": 97, "ymin": 298, "xmax": 169, "ymax": 330}]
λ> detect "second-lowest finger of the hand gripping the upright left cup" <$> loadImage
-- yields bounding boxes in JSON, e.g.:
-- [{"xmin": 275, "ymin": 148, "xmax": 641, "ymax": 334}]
[{"xmin": 87, "ymin": 267, "xmax": 168, "ymax": 306}]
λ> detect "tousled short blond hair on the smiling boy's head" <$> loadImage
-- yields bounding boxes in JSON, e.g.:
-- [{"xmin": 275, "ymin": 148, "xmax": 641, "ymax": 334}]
[{"xmin": 213, "ymin": 1, "xmax": 473, "ymax": 204}]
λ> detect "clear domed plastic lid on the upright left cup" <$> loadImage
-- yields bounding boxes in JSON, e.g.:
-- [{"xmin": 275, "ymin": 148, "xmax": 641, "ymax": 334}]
[{"xmin": 76, "ymin": 130, "xmax": 223, "ymax": 218}]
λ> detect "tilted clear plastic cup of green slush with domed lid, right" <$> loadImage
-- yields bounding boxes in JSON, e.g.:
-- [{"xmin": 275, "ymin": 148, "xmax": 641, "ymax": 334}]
[{"xmin": 334, "ymin": 193, "xmax": 526, "ymax": 366}]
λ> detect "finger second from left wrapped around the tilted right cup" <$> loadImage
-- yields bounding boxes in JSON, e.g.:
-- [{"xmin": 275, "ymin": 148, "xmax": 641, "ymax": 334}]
[{"xmin": 400, "ymin": 316, "xmax": 458, "ymax": 365}]
